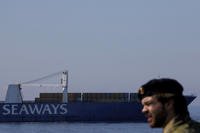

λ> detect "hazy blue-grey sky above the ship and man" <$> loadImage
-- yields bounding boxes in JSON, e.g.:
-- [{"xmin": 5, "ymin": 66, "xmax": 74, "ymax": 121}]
[{"xmin": 0, "ymin": 0, "xmax": 200, "ymax": 103}]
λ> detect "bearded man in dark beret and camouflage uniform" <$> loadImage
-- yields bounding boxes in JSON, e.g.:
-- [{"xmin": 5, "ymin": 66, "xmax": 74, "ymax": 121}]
[{"xmin": 138, "ymin": 78, "xmax": 200, "ymax": 133}]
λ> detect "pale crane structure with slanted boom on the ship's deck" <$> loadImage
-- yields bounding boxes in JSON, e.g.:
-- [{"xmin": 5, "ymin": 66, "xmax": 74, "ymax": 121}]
[{"xmin": 5, "ymin": 70, "xmax": 68, "ymax": 103}]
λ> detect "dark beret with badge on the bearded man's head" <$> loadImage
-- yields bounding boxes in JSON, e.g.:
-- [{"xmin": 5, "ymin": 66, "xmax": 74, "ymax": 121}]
[{"xmin": 138, "ymin": 78, "xmax": 183, "ymax": 100}]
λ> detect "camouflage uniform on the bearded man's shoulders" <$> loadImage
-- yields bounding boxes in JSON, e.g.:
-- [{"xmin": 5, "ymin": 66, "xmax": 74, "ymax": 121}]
[{"xmin": 163, "ymin": 117, "xmax": 200, "ymax": 133}]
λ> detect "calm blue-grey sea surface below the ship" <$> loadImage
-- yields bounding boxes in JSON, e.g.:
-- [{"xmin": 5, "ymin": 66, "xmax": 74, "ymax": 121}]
[{"xmin": 0, "ymin": 106, "xmax": 200, "ymax": 133}]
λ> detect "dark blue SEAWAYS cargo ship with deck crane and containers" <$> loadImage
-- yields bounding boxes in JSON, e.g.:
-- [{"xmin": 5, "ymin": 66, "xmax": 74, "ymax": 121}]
[{"xmin": 0, "ymin": 71, "xmax": 196, "ymax": 122}]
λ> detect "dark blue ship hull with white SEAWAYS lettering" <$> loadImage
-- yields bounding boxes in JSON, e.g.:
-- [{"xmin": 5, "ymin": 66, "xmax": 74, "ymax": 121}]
[{"xmin": 0, "ymin": 96, "xmax": 195, "ymax": 122}]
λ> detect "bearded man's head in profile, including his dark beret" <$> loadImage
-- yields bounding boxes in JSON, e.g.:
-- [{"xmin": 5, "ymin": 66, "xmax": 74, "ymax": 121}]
[{"xmin": 138, "ymin": 78, "xmax": 189, "ymax": 127}]
